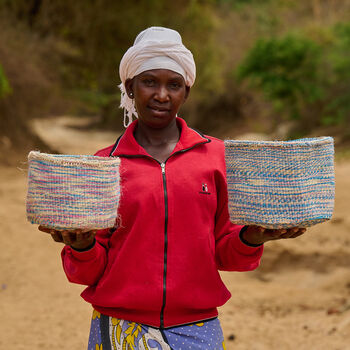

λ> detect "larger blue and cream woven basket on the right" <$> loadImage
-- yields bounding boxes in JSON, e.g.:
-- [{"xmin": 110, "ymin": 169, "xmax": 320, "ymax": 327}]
[{"xmin": 225, "ymin": 137, "xmax": 335, "ymax": 229}]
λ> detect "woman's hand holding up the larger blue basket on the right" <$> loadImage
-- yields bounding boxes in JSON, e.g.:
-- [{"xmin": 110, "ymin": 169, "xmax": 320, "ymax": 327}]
[{"xmin": 242, "ymin": 225, "xmax": 306, "ymax": 245}]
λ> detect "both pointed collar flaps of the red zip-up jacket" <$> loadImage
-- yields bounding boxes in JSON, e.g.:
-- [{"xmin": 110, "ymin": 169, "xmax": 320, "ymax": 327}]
[{"xmin": 110, "ymin": 117, "xmax": 210, "ymax": 157}]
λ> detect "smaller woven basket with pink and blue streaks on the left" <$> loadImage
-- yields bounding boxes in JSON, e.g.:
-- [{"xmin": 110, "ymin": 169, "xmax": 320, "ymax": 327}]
[{"xmin": 27, "ymin": 152, "xmax": 120, "ymax": 230}]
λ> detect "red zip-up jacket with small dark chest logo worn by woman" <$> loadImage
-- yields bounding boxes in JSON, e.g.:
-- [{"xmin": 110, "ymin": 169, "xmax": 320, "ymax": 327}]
[{"xmin": 62, "ymin": 118, "xmax": 263, "ymax": 328}]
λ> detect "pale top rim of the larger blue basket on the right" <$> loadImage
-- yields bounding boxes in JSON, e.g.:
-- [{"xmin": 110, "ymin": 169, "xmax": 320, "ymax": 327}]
[{"xmin": 224, "ymin": 136, "xmax": 334, "ymax": 148}]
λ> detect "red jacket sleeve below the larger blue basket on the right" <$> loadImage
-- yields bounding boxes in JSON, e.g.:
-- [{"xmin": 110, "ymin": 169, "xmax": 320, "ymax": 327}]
[{"xmin": 215, "ymin": 167, "xmax": 263, "ymax": 271}]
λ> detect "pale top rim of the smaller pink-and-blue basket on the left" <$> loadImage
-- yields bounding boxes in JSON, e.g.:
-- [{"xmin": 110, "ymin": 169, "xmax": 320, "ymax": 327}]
[{"xmin": 28, "ymin": 151, "xmax": 120, "ymax": 168}]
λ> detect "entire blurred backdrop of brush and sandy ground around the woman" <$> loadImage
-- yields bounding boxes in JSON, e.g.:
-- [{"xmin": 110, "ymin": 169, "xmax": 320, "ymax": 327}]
[{"xmin": 0, "ymin": 0, "xmax": 350, "ymax": 350}]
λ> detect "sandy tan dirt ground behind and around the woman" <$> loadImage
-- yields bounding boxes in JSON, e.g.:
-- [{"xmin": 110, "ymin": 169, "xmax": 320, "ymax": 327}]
[{"xmin": 0, "ymin": 118, "xmax": 350, "ymax": 350}]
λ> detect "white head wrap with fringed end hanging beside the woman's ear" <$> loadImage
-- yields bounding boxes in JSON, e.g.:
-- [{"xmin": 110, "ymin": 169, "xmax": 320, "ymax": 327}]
[{"xmin": 119, "ymin": 27, "xmax": 196, "ymax": 127}]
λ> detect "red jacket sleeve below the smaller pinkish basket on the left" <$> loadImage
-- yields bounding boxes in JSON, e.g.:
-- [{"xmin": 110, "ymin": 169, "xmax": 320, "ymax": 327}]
[{"xmin": 61, "ymin": 229, "xmax": 111, "ymax": 286}]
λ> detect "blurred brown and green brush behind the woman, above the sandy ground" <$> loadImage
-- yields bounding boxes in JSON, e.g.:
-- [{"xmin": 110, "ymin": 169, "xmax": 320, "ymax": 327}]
[{"xmin": 0, "ymin": 0, "xmax": 350, "ymax": 160}]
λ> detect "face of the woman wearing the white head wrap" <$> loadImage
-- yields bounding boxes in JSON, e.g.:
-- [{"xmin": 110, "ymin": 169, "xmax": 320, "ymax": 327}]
[{"xmin": 125, "ymin": 69, "xmax": 190, "ymax": 129}]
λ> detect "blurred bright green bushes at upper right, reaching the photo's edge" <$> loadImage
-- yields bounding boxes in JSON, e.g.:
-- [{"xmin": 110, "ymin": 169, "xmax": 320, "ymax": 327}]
[{"xmin": 237, "ymin": 23, "xmax": 350, "ymax": 132}]
